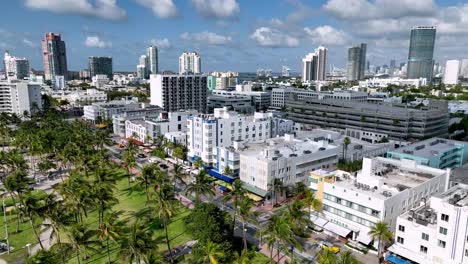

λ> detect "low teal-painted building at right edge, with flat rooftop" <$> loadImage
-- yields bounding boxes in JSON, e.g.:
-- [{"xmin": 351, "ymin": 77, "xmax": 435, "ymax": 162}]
[{"xmin": 386, "ymin": 138, "xmax": 468, "ymax": 169}]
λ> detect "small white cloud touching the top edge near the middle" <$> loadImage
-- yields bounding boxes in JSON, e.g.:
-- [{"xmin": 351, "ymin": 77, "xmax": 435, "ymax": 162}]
[{"xmin": 191, "ymin": 0, "xmax": 240, "ymax": 19}]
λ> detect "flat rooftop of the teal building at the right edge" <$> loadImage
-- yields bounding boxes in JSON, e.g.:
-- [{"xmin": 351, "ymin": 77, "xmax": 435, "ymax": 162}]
[{"xmin": 392, "ymin": 138, "xmax": 467, "ymax": 159}]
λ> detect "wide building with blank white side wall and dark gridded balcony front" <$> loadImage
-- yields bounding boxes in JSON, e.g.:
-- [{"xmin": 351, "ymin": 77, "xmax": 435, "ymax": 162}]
[{"xmin": 150, "ymin": 74, "xmax": 208, "ymax": 112}]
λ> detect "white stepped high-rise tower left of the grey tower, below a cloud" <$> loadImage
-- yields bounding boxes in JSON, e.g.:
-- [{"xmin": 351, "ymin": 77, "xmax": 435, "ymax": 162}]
[{"xmin": 302, "ymin": 47, "xmax": 328, "ymax": 82}]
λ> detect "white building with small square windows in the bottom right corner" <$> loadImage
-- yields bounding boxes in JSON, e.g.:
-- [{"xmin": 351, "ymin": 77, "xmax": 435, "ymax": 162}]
[{"xmin": 389, "ymin": 185, "xmax": 468, "ymax": 264}]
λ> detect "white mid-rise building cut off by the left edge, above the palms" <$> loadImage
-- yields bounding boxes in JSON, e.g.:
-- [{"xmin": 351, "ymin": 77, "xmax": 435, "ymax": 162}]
[{"xmin": 0, "ymin": 81, "xmax": 42, "ymax": 116}]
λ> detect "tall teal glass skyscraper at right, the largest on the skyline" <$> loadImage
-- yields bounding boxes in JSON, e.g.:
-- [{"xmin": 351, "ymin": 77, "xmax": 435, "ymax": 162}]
[{"xmin": 407, "ymin": 26, "xmax": 436, "ymax": 82}]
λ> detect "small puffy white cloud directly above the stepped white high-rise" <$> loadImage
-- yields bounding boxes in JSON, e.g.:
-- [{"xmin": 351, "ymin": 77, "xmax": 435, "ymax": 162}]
[{"xmin": 304, "ymin": 25, "xmax": 351, "ymax": 46}]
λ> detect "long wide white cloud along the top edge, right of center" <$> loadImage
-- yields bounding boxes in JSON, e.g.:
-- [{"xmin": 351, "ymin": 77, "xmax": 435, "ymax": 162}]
[{"xmin": 323, "ymin": 0, "xmax": 437, "ymax": 20}]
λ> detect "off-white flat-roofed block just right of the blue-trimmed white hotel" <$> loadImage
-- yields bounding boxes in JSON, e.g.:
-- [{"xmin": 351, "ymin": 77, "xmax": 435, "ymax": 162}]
[{"xmin": 238, "ymin": 134, "xmax": 339, "ymax": 196}]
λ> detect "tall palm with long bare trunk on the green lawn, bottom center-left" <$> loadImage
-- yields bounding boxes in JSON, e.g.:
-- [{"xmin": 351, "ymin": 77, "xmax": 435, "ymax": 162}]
[{"xmin": 154, "ymin": 184, "xmax": 177, "ymax": 263}]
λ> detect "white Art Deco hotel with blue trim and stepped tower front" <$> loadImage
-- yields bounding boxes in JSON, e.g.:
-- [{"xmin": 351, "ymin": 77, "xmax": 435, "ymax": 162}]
[{"xmin": 187, "ymin": 108, "xmax": 293, "ymax": 166}]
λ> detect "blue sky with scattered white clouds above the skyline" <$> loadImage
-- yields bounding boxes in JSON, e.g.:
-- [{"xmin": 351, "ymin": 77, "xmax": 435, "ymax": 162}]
[{"xmin": 0, "ymin": 0, "xmax": 468, "ymax": 72}]
